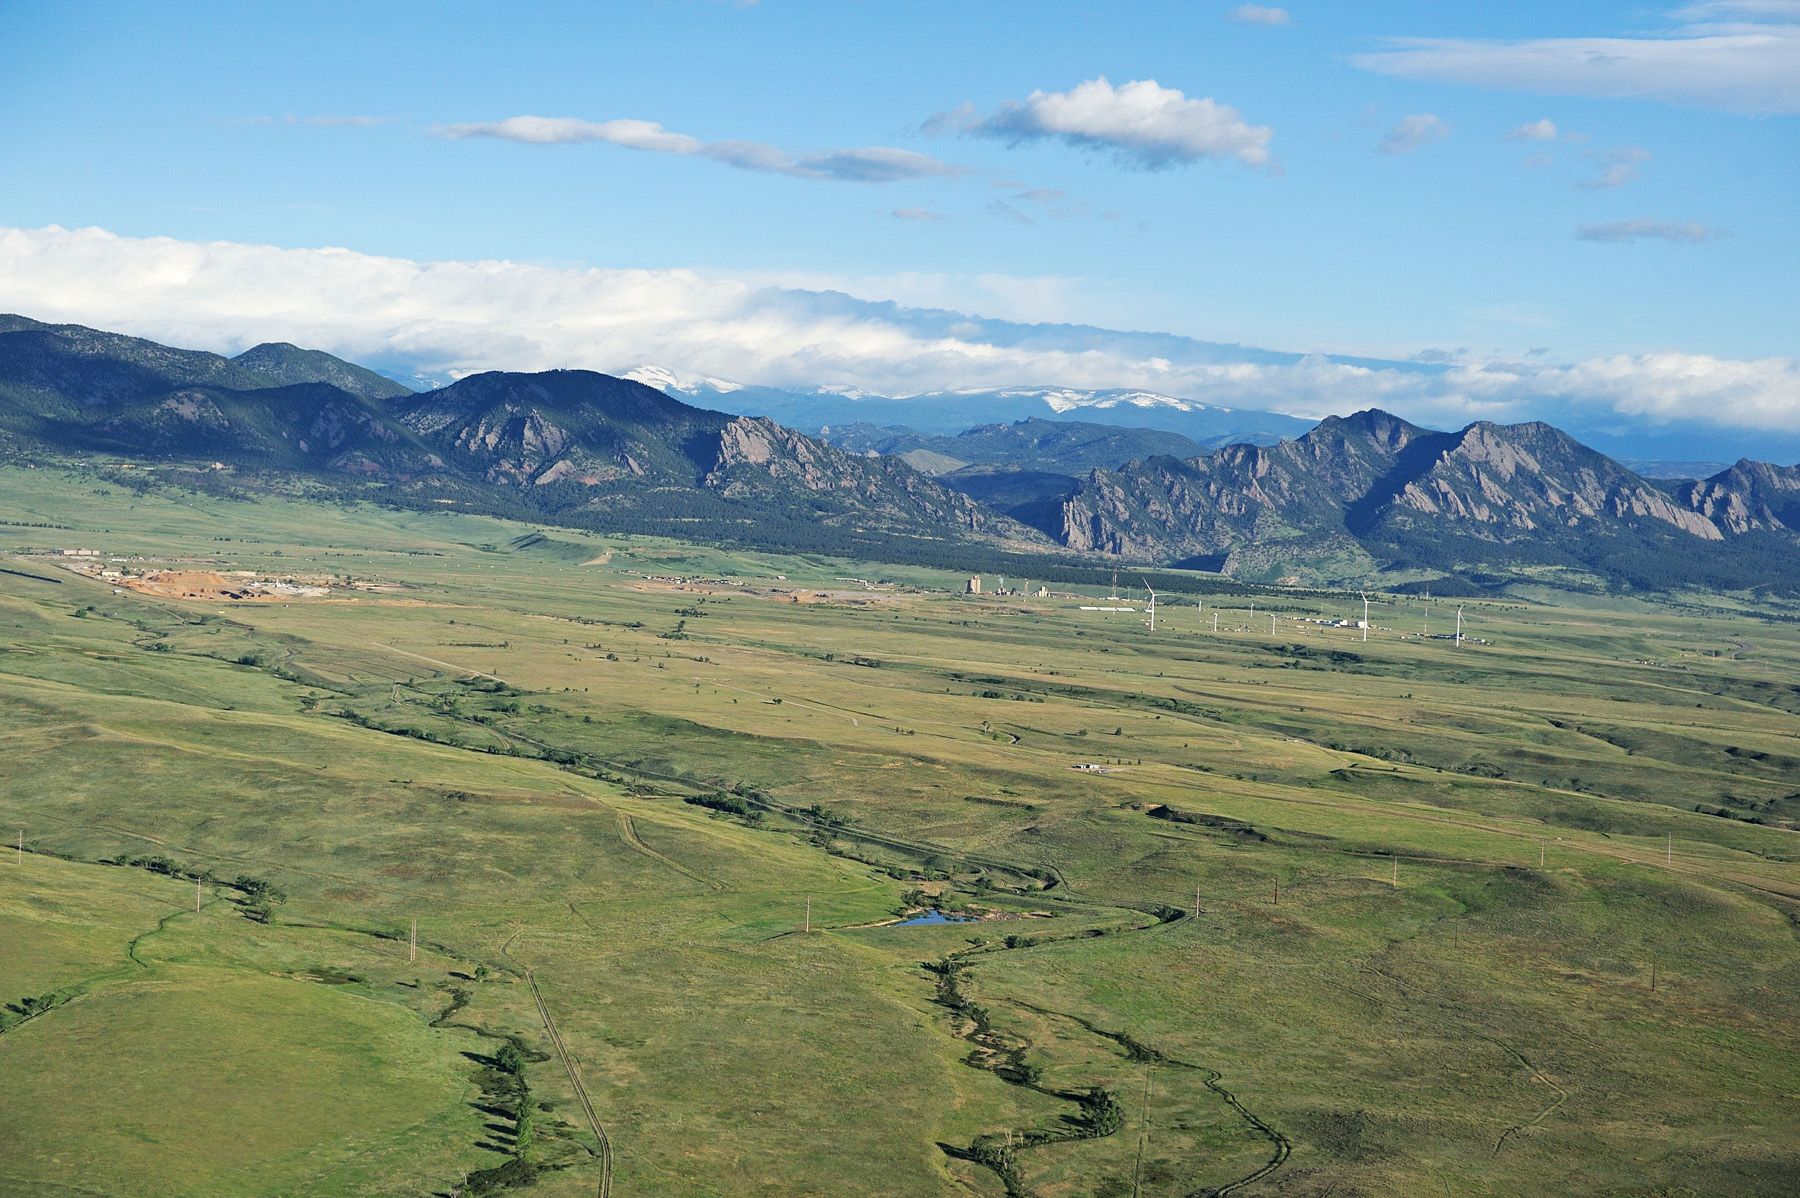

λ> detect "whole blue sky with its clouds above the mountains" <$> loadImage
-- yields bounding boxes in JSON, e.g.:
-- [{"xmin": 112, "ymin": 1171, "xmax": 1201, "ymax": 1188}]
[{"xmin": 0, "ymin": 0, "xmax": 1800, "ymax": 453}]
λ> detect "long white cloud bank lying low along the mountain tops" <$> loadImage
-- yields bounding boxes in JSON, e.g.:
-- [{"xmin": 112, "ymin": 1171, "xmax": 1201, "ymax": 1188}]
[{"xmin": 0, "ymin": 225, "xmax": 1800, "ymax": 437}]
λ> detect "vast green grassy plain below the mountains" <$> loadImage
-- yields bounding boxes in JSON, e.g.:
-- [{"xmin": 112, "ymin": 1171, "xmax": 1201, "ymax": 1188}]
[{"xmin": 0, "ymin": 468, "xmax": 1800, "ymax": 1198}]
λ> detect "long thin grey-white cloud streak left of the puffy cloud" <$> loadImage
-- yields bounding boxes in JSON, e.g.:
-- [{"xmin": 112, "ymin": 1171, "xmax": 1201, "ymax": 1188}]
[{"xmin": 432, "ymin": 117, "xmax": 965, "ymax": 183}]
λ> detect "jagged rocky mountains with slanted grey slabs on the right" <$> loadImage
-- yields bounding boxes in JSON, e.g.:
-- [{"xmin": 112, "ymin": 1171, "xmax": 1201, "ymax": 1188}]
[{"xmin": 1046, "ymin": 410, "xmax": 1800, "ymax": 588}]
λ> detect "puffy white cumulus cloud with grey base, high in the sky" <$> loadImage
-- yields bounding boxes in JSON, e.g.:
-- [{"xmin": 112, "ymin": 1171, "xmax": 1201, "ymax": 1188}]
[{"xmin": 925, "ymin": 76, "xmax": 1274, "ymax": 171}]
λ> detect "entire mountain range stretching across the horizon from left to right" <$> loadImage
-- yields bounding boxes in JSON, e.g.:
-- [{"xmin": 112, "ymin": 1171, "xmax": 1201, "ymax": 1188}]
[{"xmin": 0, "ymin": 317, "xmax": 1800, "ymax": 592}]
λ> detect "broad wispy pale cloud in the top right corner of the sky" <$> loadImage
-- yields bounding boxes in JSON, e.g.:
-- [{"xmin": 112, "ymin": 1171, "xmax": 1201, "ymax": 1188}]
[{"xmin": 1350, "ymin": 0, "xmax": 1800, "ymax": 113}]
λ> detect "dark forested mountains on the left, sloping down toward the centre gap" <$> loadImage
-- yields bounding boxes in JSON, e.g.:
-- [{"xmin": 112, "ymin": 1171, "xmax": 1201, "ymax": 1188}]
[{"xmin": 0, "ymin": 317, "xmax": 1051, "ymax": 550}]
